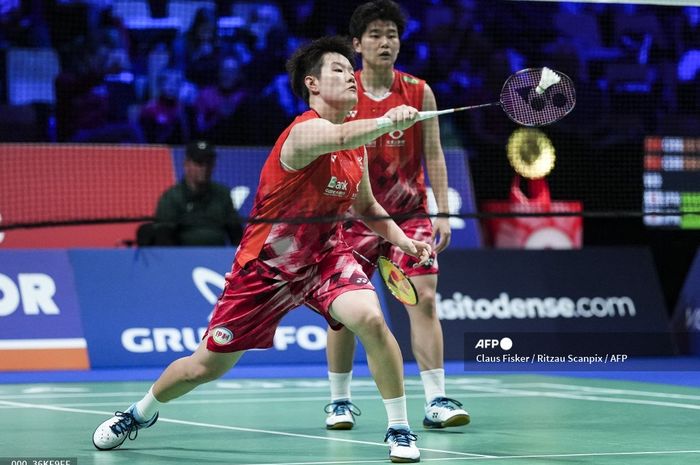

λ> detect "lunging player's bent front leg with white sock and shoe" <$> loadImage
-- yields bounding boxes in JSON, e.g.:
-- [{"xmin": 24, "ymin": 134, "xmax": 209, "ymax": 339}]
[{"xmin": 331, "ymin": 290, "xmax": 420, "ymax": 462}]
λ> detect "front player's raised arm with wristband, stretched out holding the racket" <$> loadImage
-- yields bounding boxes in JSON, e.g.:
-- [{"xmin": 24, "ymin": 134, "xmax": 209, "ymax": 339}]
[{"xmin": 282, "ymin": 105, "xmax": 418, "ymax": 169}]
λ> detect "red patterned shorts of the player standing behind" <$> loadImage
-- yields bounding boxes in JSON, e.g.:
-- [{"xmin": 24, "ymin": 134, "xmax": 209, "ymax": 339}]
[{"xmin": 343, "ymin": 218, "xmax": 438, "ymax": 278}]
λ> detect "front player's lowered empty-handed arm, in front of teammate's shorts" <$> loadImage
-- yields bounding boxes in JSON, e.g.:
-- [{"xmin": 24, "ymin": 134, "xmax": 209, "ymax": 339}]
[{"xmin": 353, "ymin": 150, "xmax": 432, "ymax": 266}]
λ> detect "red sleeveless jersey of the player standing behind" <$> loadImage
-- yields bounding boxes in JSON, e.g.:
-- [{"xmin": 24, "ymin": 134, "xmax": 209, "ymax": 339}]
[{"xmin": 348, "ymin": 70, "xmax": 427, "ymax": 215}]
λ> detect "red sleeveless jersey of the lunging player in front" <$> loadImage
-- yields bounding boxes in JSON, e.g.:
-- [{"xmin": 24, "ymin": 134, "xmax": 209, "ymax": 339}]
[{"xmin": 236, "ymin": 110, "xmax": 365, "ymax": 280}]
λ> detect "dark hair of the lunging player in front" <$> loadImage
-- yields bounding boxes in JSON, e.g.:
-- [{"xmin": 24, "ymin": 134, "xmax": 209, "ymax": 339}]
[{"xmin": 287, "ymin": 36, "xmax": 355, "ymax": 104}]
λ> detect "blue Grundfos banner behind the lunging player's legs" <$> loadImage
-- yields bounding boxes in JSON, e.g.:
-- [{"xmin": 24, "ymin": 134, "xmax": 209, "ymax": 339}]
[{"xmin": 69, "ymin": 247, "xmax": 381, "ymax": 367}]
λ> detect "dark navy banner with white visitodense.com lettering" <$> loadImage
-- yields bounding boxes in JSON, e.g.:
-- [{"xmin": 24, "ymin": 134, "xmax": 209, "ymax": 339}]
[{"xmin": 388, "ymin": 248, "xmax": 673, "ymax": 360}]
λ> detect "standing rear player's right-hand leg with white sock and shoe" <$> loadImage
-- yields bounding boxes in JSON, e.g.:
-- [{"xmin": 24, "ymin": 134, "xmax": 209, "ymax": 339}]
[{"xmin": 406, "ymin": 275, "xmax": 471, "ymax": 428}]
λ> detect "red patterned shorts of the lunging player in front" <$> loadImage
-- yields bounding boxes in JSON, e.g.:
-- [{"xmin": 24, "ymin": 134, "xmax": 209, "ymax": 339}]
[{"xmin": 207, "ymin": 246, "xmax": 374, "ymax": 352}]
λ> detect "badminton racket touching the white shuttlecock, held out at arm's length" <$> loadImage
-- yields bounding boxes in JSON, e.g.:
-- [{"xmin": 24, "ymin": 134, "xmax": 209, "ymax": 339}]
[{"xmin": 418, "ymin": 68, "xmax": 576, "ymax": 126}]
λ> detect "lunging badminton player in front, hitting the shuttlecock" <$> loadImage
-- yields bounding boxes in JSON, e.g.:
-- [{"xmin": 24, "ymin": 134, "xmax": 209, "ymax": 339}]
[{"xmin": 93, "ymin": 37, "xmax": 431, "ymax": 462}]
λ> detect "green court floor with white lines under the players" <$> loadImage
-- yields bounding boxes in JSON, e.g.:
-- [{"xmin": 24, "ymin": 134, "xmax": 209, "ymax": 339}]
[{"xmin": 0, "ymin": 374, "xmax": 700, "ymax": 465}]
